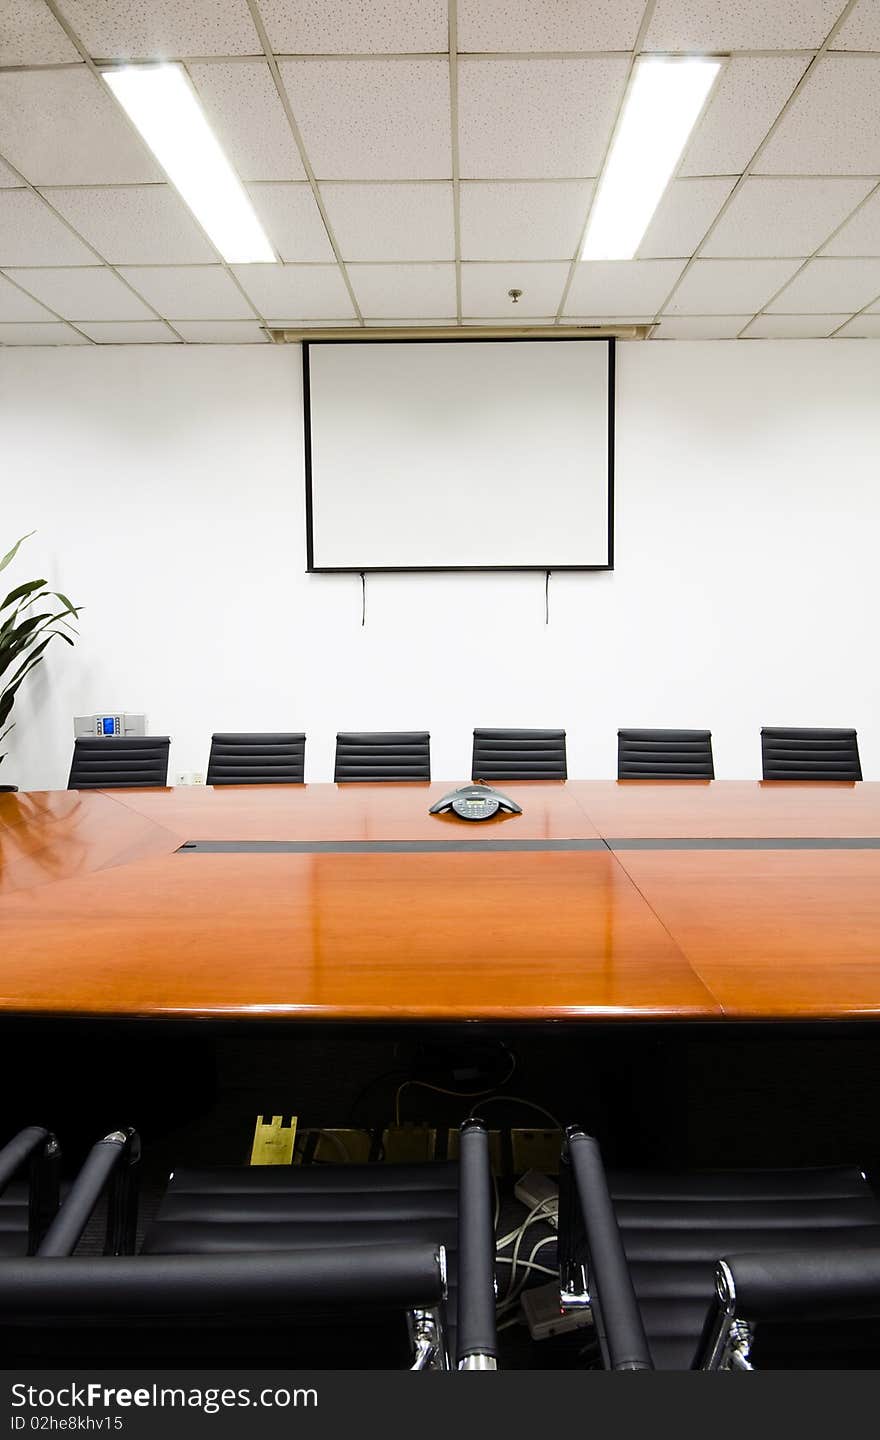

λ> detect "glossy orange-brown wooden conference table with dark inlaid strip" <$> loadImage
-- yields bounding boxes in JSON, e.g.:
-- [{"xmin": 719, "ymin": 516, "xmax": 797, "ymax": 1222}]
[{"xmin": 0, "ymin": 780, "xmax": 880, "ymax": 1021}]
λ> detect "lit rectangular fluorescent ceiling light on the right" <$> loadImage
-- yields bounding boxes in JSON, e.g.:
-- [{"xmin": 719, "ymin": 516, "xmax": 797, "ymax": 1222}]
[{"xmin": 580, "ymin": 58, "xmax": 722, "ymax": 261}]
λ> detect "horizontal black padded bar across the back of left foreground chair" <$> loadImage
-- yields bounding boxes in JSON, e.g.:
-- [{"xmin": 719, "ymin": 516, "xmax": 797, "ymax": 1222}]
[{"xmin": 0, "ymin": 1243, "xmax": 445, "ymax": 1325}]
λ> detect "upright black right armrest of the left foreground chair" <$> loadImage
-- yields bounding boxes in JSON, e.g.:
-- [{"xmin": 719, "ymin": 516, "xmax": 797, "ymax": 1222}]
[{"xmin": 457, "ymin": 1120, "xmax": 498, "ymax": 1369}]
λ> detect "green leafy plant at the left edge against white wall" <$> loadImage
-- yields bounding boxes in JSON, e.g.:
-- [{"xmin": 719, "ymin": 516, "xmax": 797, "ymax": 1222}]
[{"xmin": 0, "ymin": 530, "xmax": 82, "ymax": 791}]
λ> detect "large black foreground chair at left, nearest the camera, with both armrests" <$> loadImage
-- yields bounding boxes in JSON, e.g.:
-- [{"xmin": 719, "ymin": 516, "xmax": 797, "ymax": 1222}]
[{"xmin": 0, "ymin": 1122, "xmax": 497, "ymax": 1369}]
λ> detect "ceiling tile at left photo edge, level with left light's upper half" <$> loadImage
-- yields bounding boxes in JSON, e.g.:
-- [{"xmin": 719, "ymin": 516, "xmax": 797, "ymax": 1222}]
[{"xmin": 0, "ymin": 66, "xmax": 163, "ymax": 184}]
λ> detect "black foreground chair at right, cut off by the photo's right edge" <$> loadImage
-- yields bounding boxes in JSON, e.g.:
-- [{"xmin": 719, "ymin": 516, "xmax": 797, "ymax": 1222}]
[{"xmin": 559, "ymin": 1128, "xmax": 880, "ymax": 1369}]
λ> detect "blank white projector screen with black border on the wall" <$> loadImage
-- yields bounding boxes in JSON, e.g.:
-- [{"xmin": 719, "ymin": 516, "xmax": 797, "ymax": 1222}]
[{"xmin": 304, "ymin": 340, "xmax": 612, "ymax": 570}]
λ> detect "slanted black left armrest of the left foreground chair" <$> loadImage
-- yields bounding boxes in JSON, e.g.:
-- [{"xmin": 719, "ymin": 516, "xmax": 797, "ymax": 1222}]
[{"xmin": 36, "ymin": 1130, "xmax": 140, "ymax": 1257}]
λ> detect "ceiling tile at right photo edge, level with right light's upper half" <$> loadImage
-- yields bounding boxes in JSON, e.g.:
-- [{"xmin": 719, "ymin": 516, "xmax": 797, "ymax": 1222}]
[{"xmin": 755, "ymin": 55, "xmax": 880, "ymax": 176}]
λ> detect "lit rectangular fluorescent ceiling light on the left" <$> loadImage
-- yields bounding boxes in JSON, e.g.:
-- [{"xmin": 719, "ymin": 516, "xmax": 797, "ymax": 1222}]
[{"xmin": 102, "ymin": 65, "xmax": 277, "ymax": 265}]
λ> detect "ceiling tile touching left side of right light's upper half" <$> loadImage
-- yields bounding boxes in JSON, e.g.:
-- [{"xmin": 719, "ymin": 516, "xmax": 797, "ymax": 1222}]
[{"xmin": 458, "ymin": 56, "xmax": 629, "ymax": 180}]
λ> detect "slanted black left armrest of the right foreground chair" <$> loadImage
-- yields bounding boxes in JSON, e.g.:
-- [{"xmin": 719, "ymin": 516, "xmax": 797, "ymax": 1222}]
[{"xmin": 560, "ymin": 1129, "xmax": 654, "ymax": 1369}]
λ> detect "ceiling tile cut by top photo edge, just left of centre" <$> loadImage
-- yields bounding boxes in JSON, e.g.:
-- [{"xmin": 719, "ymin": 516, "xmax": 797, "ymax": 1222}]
[{"xmin": 259, "ymin": 0, "xmax": 448, "ymax": 55}]
